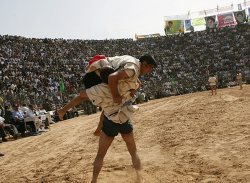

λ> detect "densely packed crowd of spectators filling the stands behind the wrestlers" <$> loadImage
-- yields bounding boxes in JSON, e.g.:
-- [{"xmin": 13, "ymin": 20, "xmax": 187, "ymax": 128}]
[{"xmin": 0, "ymin": 24, "xmax": 250, "ymax": 109}]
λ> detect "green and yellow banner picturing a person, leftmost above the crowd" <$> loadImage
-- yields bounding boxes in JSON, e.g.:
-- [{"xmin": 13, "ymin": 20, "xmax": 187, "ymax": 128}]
[{"xmin": 164, "ymin": 20, "xmax": 184, "ymax": 35}]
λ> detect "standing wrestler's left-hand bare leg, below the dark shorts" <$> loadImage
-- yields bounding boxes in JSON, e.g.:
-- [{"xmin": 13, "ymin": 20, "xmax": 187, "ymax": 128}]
[{"xmin": 91, "ymin": 133, "xmax": 114, "ymax": 183}]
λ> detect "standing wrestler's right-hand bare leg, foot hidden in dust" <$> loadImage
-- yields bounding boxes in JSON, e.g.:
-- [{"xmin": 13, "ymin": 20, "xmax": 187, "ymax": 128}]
[{"xmin": 122, "ymin": 132, "xmax": 141, "ymax": 170}]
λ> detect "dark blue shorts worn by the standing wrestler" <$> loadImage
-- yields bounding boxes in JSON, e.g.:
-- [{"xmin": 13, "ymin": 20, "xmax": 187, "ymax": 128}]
[{"xmin": 102, "ymin": 116, "xmax": 133, "ymax": 137}]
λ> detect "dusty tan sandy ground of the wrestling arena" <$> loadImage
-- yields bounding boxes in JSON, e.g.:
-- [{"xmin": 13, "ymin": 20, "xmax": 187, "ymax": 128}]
[{"xmin": 0, "ymin": 85, "xmax": 250, "ymax": 183}]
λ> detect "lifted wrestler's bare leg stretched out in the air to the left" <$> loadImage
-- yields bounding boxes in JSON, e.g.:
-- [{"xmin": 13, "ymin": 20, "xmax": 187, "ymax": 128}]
[{"xmin": 57, "ymin": 90, "xmax": 89, "ymax": 120}]
